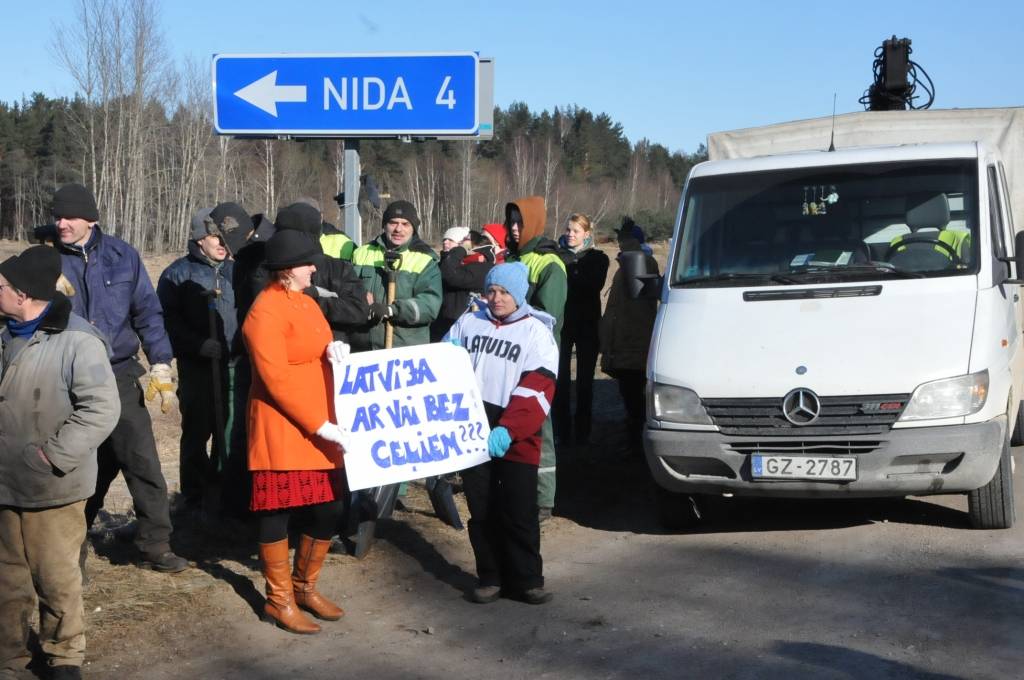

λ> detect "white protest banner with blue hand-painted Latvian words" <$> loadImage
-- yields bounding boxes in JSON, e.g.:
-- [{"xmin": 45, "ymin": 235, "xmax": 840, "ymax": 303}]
[{"xmin": 332, "ymin": 342, "xmax": 490, "ymax": 491}]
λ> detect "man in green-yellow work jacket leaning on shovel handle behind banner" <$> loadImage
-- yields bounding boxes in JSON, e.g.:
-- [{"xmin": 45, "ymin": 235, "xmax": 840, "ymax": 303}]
[{"xmin": 351, "ymin": 201, "xmax": 441, "ymax": 351}]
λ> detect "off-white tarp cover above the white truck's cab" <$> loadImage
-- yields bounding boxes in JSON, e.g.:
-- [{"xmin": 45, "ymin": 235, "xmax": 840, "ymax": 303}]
[{"xmin": 708, "ymin": 108, "xmax": 1024, "ymax": 230}]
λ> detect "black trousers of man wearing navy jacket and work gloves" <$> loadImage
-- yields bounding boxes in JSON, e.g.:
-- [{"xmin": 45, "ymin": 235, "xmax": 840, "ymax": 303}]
[{"xmin": 85, "ymin": 362, "xmax": 171, "ymax": 555}]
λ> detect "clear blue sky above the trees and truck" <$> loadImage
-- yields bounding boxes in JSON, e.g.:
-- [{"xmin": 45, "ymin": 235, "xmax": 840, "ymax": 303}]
[{"xmin": 0, "ymin": 0, "xmax": 1024, "ymax": 151}]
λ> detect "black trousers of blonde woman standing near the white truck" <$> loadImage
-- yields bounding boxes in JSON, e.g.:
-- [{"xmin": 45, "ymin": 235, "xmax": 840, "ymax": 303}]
[{"xmin": 551, "ymin": 324, "xmax": 599, "ymax": 443}]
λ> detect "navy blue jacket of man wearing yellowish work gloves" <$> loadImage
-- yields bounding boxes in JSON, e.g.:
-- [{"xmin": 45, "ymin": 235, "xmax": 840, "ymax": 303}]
[{"xmin": 59, "ymin": 226, "xmax": 173, "ymax": 371}]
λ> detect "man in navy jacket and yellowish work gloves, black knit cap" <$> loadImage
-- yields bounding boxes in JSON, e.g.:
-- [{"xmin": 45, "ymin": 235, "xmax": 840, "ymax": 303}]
[{"xmin": 52, "ymin": 184, "xmax": 188, "ymax": 572}]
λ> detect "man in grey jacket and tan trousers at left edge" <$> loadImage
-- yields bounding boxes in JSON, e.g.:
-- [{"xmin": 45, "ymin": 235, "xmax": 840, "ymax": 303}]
[{"xmin": 0, "ymin": 246, "xmax": 121, "ymax": 678}]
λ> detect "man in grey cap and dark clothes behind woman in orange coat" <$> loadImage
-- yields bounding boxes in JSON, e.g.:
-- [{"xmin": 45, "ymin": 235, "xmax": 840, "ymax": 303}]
[{"xmin": 157, "ymin": 203, "xmax": 241, "ymax": 512}]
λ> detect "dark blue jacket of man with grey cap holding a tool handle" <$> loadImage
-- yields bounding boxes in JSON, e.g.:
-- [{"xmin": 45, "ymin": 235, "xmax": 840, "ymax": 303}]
[{"xmin": 157, "ymin": 241, "xmax": 239, "ymax": 360}]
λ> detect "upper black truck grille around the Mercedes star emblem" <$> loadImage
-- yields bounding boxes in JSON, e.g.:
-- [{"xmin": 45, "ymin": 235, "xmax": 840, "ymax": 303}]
[{"xmin": 702, "ymin": 394, "xmax": 910, "ymax": 437}]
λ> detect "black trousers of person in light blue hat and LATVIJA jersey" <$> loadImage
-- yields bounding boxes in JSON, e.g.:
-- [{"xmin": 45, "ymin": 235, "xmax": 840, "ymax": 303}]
[{"xmin": 462, "ymin": 459, "xmax": 544, "ymax": 592}]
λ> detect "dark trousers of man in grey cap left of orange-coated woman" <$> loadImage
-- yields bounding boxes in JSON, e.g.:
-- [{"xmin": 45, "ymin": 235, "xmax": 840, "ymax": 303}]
[{"xmin": 178, "ymin": 359, "xmax": 230, "ymax": 504}]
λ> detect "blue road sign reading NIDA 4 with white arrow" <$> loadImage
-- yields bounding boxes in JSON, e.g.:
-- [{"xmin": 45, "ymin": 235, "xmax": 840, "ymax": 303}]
[{"xmin": 213, "ymin": 52, "xmax": 479, "ymax": 137}]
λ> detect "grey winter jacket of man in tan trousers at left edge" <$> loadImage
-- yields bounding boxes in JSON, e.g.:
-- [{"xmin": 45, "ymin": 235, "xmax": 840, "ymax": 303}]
[{"xmin": 0, "ymin": 293, "xmax": 121, "ymax": 508}]
